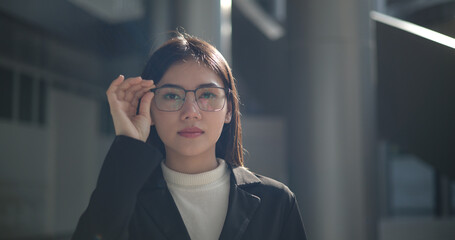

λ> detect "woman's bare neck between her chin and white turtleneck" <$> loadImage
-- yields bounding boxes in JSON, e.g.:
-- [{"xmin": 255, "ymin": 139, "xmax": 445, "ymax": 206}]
[{"xmin": 164, "ymin": 150, "xmax": 218, "ymax": 174}]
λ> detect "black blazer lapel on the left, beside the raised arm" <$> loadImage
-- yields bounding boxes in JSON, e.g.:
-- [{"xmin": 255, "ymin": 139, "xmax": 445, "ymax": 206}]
[{"xmin": 138, "ymin": 167, "xmax": 191, "ymax": 240}]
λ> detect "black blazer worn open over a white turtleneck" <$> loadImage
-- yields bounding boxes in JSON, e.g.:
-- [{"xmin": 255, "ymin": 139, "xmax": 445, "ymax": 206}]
[{"xmin": 72, "ymin": 136, "xmax": 306, "ymax": 240}]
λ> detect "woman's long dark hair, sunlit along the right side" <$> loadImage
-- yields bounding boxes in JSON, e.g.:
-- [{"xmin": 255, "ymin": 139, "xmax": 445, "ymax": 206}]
[{"xmin": 141, "ymin": 32, "xmax": 243, "ymax": 166}]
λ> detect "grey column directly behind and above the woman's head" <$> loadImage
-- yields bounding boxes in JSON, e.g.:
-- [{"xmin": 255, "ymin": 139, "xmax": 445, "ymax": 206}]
[{"xmin": 146, "ymin": 0, "xmax": 232, "ymax": 62}]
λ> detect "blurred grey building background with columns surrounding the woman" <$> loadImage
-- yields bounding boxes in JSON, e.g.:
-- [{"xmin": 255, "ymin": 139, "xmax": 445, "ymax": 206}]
[{"xmin": 0, "ymin": 0, "xmax": 455, "ymax": 240}]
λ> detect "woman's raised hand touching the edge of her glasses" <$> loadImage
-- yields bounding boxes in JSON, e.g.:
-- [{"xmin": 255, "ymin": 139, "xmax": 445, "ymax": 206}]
[{"xmin": 106, "ymin": 75, "xmax": 155, "ymax": 142}]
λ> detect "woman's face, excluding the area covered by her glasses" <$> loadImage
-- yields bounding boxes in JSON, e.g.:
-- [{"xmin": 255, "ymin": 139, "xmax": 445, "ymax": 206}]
[{"xmin": 151, "ymin": 61, "xmax": 232, "ymax": 157}]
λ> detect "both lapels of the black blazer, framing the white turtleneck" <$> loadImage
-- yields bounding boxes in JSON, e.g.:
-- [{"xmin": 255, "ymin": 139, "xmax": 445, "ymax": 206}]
[{"xmin": 138, "ymin": 164, "xmax": 261, "ymax": 240}]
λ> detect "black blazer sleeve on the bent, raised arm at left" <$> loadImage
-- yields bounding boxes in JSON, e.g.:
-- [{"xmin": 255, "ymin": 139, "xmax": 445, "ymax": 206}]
[{"xmin": 72, "ymin": 136, "xmax": 163, "ymax": 240}]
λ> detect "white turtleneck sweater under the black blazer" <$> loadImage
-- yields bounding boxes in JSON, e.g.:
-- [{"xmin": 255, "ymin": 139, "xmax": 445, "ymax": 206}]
[{"xmin": 161, "ymin": 159, "xmax": 230, "ymax": 240}]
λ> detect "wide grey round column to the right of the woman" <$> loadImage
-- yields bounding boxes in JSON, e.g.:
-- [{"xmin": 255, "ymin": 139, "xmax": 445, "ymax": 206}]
[{"xmin": 287, "ymin": 0, "xmax": 377, "ymax": 240}]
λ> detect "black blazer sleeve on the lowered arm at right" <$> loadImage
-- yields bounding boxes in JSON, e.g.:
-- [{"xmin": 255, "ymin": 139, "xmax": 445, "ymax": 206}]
[{"xmin": 280, "ymin": 194, "xmax": 307, "ymax": 240}]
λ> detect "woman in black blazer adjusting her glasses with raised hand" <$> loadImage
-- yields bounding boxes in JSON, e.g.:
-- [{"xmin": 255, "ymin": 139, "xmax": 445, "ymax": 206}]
[{"xmin": 73, "ymin": 34, "xmax": 306, "ymax": 239}]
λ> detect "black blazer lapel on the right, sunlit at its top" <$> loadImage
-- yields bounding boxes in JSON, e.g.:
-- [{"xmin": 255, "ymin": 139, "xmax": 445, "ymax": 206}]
[{"xmin": 220, "ymin": 167, "xmax": 261, "ymax": 240}]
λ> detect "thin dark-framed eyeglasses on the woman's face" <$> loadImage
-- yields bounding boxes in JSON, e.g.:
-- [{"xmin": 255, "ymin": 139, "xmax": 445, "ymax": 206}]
[{"xmin": 150, "ymin": 86, "xmax": 230, "ymax": 112}]
